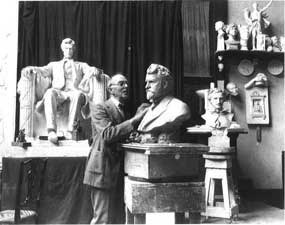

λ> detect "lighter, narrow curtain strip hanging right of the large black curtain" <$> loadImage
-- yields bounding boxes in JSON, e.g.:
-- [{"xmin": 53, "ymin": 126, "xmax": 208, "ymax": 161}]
[{"xmin": 181, "ymin": 1, "xmax": 210, "ymax": 77}]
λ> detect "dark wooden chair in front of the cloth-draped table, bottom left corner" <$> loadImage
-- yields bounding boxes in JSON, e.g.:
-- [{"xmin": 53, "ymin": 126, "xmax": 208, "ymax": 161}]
[{"xmin": 0, "ymin": 158, "xmax": 47, "ymax": 224}]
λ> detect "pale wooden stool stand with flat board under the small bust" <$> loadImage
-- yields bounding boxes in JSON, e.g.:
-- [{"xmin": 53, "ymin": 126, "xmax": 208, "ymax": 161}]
[{"xmin": 188, "ymin": 127, "xmax": 247, "ymax": 219}]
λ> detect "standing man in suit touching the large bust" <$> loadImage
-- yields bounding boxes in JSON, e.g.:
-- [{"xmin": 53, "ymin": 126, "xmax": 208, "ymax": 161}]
[{"xmin": 83, "ymin": 74, "xmax": 146, "ymax": 224}]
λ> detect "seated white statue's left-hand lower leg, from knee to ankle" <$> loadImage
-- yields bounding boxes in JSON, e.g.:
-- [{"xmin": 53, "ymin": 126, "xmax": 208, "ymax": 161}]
[{"xmin": 44, "ymin": 88, "xmax": 58, "ymax": 131}]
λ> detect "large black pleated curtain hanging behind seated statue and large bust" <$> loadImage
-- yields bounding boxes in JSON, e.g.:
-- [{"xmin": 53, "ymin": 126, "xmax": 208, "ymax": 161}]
[{"xmin": 16, "ymin": 1, "xmax": 183, "ymax": 134}]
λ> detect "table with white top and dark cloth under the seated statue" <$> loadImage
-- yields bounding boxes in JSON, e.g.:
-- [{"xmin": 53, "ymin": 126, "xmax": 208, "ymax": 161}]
[{"xmin": 1, "ymin": 142, "xmax": 93, "ymax": 224}]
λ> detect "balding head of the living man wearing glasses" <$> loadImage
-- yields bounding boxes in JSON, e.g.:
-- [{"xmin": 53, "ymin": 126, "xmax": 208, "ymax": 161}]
[{"xmin": 108, "ymin": 74, "xmax": 128, "ymax": 102}]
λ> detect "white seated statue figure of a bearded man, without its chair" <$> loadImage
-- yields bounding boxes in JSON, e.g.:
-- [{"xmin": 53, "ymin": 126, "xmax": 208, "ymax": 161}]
[{"xmin": 22, "ymin": 38, "xmax": 103, "ymax": 144}]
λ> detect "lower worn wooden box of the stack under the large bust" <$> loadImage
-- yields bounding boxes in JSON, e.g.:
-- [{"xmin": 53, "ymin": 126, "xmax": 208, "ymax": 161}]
[{"xmin": 125, "ymin": 177, "xmax": 205, "ymax": 214}]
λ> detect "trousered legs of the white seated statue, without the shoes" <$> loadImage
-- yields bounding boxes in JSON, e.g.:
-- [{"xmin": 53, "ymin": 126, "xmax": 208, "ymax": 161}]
[{"xmin": 43, "ymin": 88, "xmax": 85, "ymax": 131}]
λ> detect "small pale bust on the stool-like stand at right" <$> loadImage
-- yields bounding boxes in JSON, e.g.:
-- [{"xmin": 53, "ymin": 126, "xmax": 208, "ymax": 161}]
[{"xmin": 202, "ymin": 88, "xmax": 237, "ymax": 130}]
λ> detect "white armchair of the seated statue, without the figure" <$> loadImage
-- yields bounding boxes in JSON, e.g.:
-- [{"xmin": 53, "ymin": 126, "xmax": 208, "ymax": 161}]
[{"xmin": 17, "ymin": 69, "xmax": 110, "ymax": 139}]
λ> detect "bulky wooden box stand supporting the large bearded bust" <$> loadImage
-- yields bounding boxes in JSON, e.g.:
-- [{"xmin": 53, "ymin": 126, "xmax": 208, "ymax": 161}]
[{"xmin": 121, "ymin": 143, "xmax": 209, "ymax": 224}]
